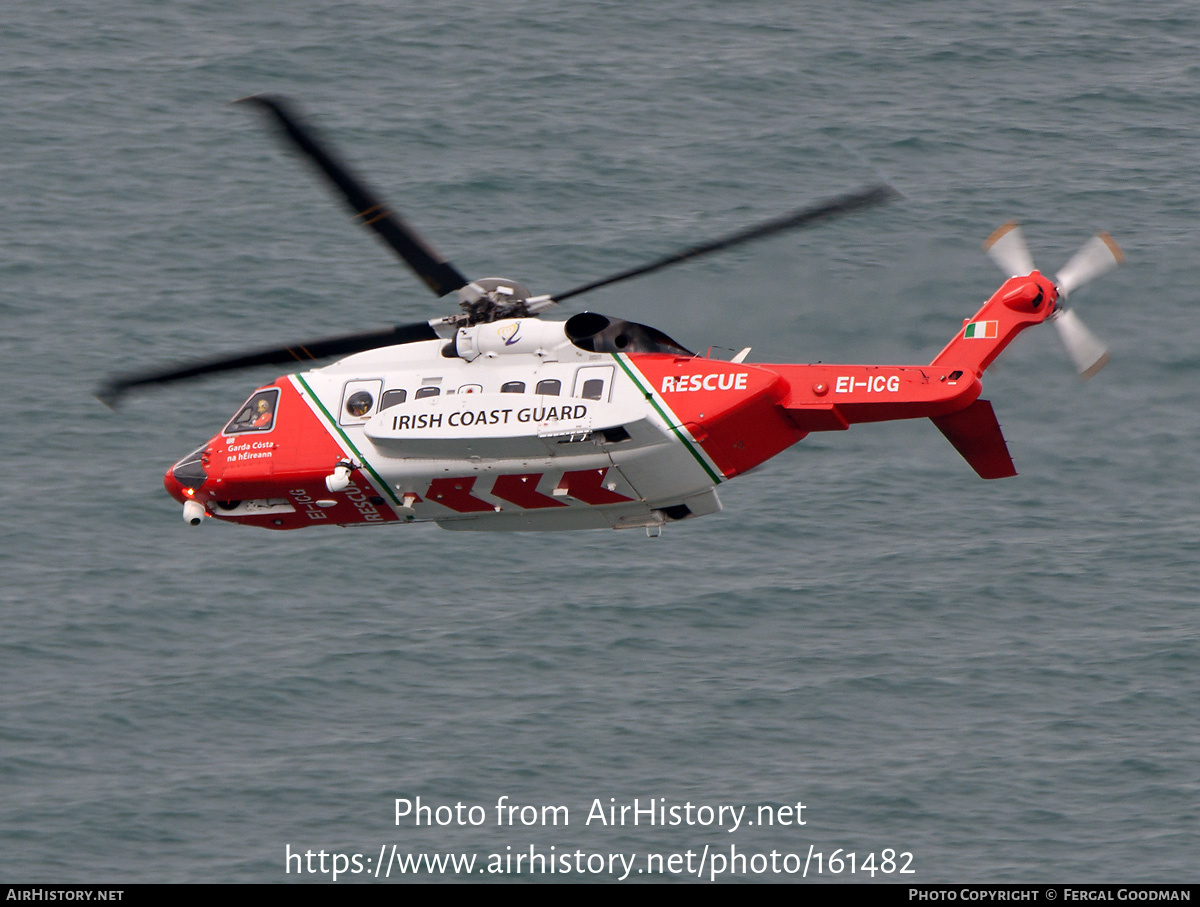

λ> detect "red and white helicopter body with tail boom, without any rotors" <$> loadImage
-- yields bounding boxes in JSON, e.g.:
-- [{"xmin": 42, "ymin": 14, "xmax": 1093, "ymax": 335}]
[{"xmin": 164, "ymin": 272, "xmax": 1054, "ymax": 530}]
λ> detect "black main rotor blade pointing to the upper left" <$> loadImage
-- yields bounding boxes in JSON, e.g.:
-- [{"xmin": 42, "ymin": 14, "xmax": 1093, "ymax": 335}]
[{"xmin": 235, "ymin": 95, "xmax": 467, "ymax": 296}]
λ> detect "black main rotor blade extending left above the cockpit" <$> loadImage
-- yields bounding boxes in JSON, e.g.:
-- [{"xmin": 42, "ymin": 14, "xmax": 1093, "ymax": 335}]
[{"xmin": 96, "ymin": 322, "xmax": 438, "ymax": 408}]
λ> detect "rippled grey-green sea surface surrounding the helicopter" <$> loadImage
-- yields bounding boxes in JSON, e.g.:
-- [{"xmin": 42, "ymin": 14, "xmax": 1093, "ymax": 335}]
[{"xmin": 0, "ymin": 0, "xmax": 1200, "ymax": 883}]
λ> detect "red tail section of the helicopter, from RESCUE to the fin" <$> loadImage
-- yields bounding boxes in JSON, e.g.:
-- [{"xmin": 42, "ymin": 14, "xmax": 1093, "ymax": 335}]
[{"xmin": 628, "ymin": 271, "xmax": 1057, "ymax": 477}]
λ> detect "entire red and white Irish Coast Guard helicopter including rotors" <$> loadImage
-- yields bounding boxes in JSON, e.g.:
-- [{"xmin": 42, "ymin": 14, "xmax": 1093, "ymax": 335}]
[{"xmin": 96, "ymin": 95, "xmax": 1122, "ymax": 536}]
